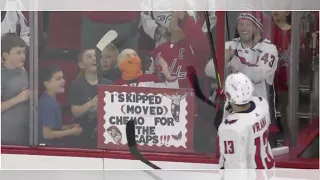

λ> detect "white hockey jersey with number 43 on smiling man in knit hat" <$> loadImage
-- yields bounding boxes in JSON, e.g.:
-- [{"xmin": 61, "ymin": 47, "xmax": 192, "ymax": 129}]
[{"xmin": 225, "ymin": 38, "xmax": 278, "ymax": 99}]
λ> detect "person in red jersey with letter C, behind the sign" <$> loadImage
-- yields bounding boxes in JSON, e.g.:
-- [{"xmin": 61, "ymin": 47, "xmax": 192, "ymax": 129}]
[{"xmin": 153, "ymin": 11, "xmax": 210, "ymax": 88}]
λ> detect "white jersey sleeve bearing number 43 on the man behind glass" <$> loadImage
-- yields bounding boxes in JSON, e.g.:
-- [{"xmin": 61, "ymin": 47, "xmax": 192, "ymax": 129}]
[{"xmin": 252, "ymin": 41, "xmax": 278, "ymax": 85}]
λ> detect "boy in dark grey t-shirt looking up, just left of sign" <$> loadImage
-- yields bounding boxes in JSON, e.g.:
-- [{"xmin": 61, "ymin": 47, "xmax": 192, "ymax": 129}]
[{"xmin": 69, "ymin": 49, "xmax": 111, "ymax": 148}]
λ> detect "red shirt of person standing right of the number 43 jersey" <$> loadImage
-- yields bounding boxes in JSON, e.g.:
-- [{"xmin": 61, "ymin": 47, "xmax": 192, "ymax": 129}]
[{"xmin": 272, "ymin": 24, "xmax": 291, "ymax": 91}]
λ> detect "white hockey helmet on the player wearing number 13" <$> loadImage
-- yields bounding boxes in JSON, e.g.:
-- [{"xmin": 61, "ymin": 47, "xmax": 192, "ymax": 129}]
[{"xmin": 225, "ymin": 73, "xmax": 254, "ymax": 105}]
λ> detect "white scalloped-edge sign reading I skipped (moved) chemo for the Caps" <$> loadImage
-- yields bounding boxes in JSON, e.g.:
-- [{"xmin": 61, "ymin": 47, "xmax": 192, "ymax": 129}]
[{"xmin": 104, "ymin": 91, "xmax": 187, "ymax": 147}]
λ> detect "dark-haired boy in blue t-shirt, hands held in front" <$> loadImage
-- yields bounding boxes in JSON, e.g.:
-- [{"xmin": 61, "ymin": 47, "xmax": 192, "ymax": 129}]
[{"xmin": 38, "ymin": 67, "xmax": 82, "ymax": 146}]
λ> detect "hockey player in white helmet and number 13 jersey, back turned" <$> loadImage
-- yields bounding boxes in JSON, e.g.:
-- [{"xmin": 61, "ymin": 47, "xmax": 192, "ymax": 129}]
[{"xmin": 218, "ymin": 73, "xmax": 275, "ymax": 169}]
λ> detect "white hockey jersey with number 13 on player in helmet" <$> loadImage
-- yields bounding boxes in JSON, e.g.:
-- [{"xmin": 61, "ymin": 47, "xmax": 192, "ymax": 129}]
[{"xmin": 218, "ymin": 96, "xmax": 275, "ymax": 169}]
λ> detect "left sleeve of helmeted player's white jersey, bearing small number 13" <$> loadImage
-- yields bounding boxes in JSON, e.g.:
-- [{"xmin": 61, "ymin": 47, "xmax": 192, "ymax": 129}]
[{"xmin": 219, "ymin": 122, "xmax": 249, "ymax": 169}]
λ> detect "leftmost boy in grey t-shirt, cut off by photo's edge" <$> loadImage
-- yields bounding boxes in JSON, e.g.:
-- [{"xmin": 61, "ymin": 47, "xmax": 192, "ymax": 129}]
[{"xmin": 1, "ymin": 34, "xmax": 30, "ymax": 145}]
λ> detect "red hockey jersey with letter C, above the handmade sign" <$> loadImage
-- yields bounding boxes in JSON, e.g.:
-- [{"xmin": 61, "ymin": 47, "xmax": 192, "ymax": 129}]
[{"xmin": 153, "ymin": 17, "xmax": 209, "ymax": 88}]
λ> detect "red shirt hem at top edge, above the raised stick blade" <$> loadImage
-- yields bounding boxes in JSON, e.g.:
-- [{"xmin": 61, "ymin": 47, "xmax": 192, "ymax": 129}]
[{"xmin": 83, "ymin": 11, "xmax": 140, "ymax": 24}]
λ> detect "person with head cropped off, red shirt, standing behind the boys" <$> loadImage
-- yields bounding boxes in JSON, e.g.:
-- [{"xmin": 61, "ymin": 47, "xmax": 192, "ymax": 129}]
[{"xmin": 81, "ymin": 11, "xmax": 140, "ymax": 51}]
